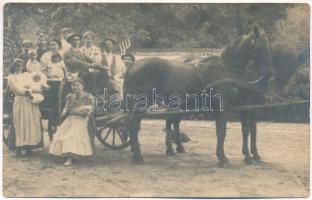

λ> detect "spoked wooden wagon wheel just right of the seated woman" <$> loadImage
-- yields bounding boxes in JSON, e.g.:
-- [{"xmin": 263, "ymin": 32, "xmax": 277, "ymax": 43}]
[{"xmin": 95, "ymin": 125, "xmax": 130, "ymax": 150}]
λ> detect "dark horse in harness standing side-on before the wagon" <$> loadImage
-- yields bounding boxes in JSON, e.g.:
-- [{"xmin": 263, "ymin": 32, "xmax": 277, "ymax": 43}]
[{"xmin": 124, "ymin": 25, "xmax": 272, "ymax": 166}]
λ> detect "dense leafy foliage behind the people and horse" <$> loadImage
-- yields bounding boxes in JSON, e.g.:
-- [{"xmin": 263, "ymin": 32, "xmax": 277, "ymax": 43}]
[{"xmin": 4, "ymin": 3, "xmax": 310, "ymax": 121}]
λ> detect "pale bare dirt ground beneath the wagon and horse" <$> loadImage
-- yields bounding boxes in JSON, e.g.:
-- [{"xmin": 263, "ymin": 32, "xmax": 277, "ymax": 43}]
[{"xmin": 3, "ymin": 120, "xmax": 310, "ymax": 197}]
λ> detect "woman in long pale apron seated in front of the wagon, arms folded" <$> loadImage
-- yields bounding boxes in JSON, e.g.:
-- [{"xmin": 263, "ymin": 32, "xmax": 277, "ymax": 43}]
[{"xmin": 49, "ymin": 78, "xmax": 93, "ymax": 166}]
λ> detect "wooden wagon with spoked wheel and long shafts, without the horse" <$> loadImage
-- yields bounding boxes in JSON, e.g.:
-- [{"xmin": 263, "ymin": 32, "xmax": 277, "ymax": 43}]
[{"xmin": 3, "ymin": 69, "xmax": 309, "ymax": 166}]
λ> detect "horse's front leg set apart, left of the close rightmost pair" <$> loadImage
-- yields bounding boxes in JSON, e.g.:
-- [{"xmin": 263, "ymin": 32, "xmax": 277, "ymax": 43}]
[{"xmin": 216, "ymin": 113, "xmax": 229, "ymax": 167}]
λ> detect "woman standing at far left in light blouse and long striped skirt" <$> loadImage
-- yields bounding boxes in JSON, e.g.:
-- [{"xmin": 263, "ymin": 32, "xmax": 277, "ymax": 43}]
[{"xmin": 8, "ymin": 59, "xmax": 43, "ymax": 155}]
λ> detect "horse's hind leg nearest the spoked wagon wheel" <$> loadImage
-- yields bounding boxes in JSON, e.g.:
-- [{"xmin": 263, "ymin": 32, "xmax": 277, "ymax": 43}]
[{"xmin": 129, "ymin": 119, "xmax": 143, "ymax": 164}]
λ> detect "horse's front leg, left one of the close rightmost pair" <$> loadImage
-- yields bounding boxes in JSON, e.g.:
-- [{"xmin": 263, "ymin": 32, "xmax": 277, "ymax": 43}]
[{"xmin": 242, "ymin": 112, "xmax": 252, "ymax": 164}]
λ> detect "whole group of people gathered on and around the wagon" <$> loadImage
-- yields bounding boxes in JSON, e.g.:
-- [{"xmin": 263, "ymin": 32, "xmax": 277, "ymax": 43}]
[{"xmin": 7, "ymin": 28, "xmax": 135, "ymax": 166}]
